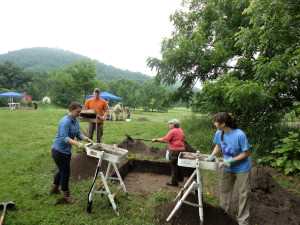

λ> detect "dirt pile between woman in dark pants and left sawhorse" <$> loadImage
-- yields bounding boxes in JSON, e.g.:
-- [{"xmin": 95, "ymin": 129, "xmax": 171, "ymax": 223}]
[{"xmin": 71, "ymin": 152, "xmax": 107, "ymax": 181}]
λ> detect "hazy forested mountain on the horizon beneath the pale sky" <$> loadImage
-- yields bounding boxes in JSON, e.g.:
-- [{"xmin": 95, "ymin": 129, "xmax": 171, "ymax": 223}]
[{"xmin": 0, "ymin": 47, "xmax": 150, "ymax": 81}]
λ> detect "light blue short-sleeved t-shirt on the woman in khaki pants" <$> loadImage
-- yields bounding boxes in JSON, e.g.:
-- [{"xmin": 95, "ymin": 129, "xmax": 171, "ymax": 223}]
[{"xmin": 214, "ymin": 129, "xmax": 251, "ymax": 173}]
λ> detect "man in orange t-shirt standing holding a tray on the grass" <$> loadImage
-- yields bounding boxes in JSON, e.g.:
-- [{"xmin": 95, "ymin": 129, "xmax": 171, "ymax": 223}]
[{"xmin": 84, "ymin": 88, "xmax": 108, "ymax": 143}]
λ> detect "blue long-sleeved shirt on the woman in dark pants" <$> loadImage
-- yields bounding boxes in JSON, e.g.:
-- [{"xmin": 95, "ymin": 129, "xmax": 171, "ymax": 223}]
[{"xmin": 52, "ymin": 115, "xmax": 83, "ymax": 155}]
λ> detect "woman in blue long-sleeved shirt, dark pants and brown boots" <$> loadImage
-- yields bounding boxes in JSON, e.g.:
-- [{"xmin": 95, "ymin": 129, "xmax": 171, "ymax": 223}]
[{"xmin": 50, "ymin": 102, "xmax": 92, "ymax": 203}]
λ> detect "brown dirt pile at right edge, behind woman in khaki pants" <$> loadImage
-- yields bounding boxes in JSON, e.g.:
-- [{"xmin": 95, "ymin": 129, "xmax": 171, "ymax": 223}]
[{"xmin": 250, "ymin": 167, "xmax": 300, "ymax": 225}]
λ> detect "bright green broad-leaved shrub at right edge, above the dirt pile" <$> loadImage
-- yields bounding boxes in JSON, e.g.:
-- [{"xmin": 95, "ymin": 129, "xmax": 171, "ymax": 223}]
[{"xmin": 258, "ymin": 132, "xmax": 300, "ymax": 175}]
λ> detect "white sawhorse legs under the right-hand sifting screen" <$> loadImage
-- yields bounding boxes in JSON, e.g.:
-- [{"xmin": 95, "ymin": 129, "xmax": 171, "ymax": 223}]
[{"xmin": 167, "ymin": 158, "xmax": 203, "ymax": 225}]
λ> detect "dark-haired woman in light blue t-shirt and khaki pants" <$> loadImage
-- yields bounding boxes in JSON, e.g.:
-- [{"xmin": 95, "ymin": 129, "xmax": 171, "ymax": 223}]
[{"xmin": 207, "ymin": 112, "xmax": 251, "ymax": 225}]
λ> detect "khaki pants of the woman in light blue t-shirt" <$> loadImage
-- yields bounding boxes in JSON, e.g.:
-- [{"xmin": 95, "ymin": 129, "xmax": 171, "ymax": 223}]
[{"xmin": 220, "ymin": 171, "xmax": 250, "ymax": 225}]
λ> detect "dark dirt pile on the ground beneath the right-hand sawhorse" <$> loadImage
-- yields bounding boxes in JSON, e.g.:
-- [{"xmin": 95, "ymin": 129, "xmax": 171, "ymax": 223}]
[{"xmin": 156, "ymin": 194, "xmax": 238, "ymax": 225}]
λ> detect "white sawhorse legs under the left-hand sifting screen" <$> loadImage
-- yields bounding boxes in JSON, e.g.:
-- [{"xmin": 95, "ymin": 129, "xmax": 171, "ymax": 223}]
[{"xmin": 87, "ymin": 151, "xmax": 127, "ymax": 215}]
